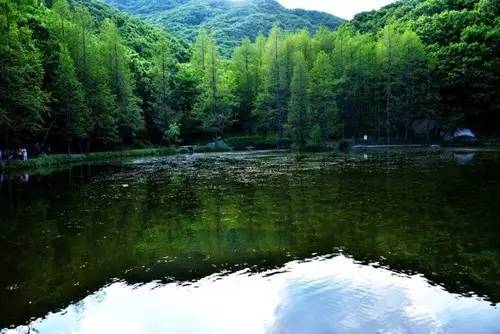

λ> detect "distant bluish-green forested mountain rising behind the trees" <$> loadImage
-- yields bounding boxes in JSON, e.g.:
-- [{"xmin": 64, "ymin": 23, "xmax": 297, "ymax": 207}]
[{"xmin": 103, "ymin": 0, "xmax": 343, "ymax": 55}]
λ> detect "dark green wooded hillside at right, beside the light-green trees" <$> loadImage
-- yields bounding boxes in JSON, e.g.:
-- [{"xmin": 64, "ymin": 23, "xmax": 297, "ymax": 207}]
[{"xmin": 349, "ymin": 0, "xmax": 500, "ymax": 132}]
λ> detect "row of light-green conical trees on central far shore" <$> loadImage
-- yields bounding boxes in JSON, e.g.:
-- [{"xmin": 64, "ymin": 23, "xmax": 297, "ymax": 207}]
[{"xmin": 191, "ymin": 25, "xmax": 438, "ymax": 145}]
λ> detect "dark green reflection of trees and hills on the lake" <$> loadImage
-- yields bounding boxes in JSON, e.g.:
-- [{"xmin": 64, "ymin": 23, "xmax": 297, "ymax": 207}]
[{"xmin": 0, "ymin": 152, "xmax": 500, "ymax": 327}]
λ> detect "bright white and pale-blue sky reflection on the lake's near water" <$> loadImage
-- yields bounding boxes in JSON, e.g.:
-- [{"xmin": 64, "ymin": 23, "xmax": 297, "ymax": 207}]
[{"xmin": 5, "ymin": 255, "xmax": 500, "ymax": 334}]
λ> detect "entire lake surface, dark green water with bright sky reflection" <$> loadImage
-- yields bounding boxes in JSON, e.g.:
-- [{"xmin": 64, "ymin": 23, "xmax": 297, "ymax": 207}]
[{"xmin": 0, "ymin": 150, "xmax": 500, "ymax": 334}]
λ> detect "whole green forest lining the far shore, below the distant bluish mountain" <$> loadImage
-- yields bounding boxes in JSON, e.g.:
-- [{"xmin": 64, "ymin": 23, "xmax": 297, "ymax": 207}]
[{"xmin": 0, "ymin": 0, "xmax": 500, "ymax": 153}]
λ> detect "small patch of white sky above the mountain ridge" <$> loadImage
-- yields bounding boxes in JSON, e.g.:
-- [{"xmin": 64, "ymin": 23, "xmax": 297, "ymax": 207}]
[{"xmin": 278, "ymin": 0, "xmax": 394, "ymax": 19}]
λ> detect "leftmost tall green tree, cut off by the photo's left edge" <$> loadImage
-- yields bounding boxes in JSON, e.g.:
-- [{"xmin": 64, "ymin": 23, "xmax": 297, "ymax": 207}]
[{"xmin": 0, "ymin": 0, "xmax": 47, "ymax": 145}]
